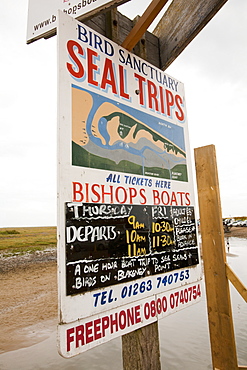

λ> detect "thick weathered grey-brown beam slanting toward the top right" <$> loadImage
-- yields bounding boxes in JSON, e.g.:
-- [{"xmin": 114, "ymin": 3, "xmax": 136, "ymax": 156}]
[{"xmin": 153, "ymin": 0, "xmax": 227, "ymax": 70}]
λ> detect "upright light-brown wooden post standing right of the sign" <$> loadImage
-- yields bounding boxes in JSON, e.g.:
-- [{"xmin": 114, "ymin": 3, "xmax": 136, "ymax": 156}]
[{"xmin": 195, "ymin": 145, "xmax": 238, "ymax": 370}]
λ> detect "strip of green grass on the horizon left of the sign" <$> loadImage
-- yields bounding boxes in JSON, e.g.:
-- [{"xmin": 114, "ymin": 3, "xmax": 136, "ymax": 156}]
[{"xmin": 0, "ymin": 227, "xmax": 57, "ymax": 255}]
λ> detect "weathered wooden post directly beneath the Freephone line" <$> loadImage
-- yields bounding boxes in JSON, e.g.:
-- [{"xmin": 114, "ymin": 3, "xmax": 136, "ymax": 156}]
[{"xmin": 122, "ymin": 322, "xmax": 161, "ymax": 370}]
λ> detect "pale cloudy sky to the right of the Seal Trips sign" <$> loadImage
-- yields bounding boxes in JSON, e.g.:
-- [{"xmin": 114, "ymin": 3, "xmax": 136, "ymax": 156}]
[{"xmin": 167, "ymin": 0, "xmax": 247, "ymax": 216}]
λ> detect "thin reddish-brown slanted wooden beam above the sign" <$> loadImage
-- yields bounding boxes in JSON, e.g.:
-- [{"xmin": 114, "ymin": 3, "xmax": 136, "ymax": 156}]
[{"xmin": 122, "ymin": 0, "xmax": 168, "ymax": 51}]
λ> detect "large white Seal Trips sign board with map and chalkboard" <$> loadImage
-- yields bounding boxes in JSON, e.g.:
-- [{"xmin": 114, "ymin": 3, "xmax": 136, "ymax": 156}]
[{"xmin": 58, "ymin": 12, "xmax": 201, "ymax": 357}]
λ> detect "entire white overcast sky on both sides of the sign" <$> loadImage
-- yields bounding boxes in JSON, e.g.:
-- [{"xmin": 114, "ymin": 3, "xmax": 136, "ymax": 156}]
[{"xmin": 0, "ymin": 0, "xmax": 247, "ymax": 226}]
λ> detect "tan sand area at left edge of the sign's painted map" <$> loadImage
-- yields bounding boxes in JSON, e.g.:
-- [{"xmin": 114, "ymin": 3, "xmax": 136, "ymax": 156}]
[{"xmin": 72, "ymin": 88, "xmax": 93, "ymax": 145}]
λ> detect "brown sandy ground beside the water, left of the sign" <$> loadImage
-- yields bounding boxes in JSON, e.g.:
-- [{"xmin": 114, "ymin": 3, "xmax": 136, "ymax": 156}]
[{"xmin": 0, "ymin": 261, "xmax": 57, "ymax": 353}]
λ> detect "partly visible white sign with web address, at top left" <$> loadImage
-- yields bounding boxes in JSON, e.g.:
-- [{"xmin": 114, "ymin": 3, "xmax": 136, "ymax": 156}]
[{"xmin": 27, "ymin": 0, "xmax": 129, "ymax": 44}]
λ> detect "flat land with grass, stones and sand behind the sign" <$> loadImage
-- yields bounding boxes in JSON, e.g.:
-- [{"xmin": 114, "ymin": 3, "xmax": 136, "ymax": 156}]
[{"xmin": 0, "ymin": 227, "xmax": 247, "ymax": 353}]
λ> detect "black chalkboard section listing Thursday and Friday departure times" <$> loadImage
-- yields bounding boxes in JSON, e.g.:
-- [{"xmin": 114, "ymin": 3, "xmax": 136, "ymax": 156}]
[{"xmin": 65, "ymin": 203, "xmax": 199, "ymax": 295}]
